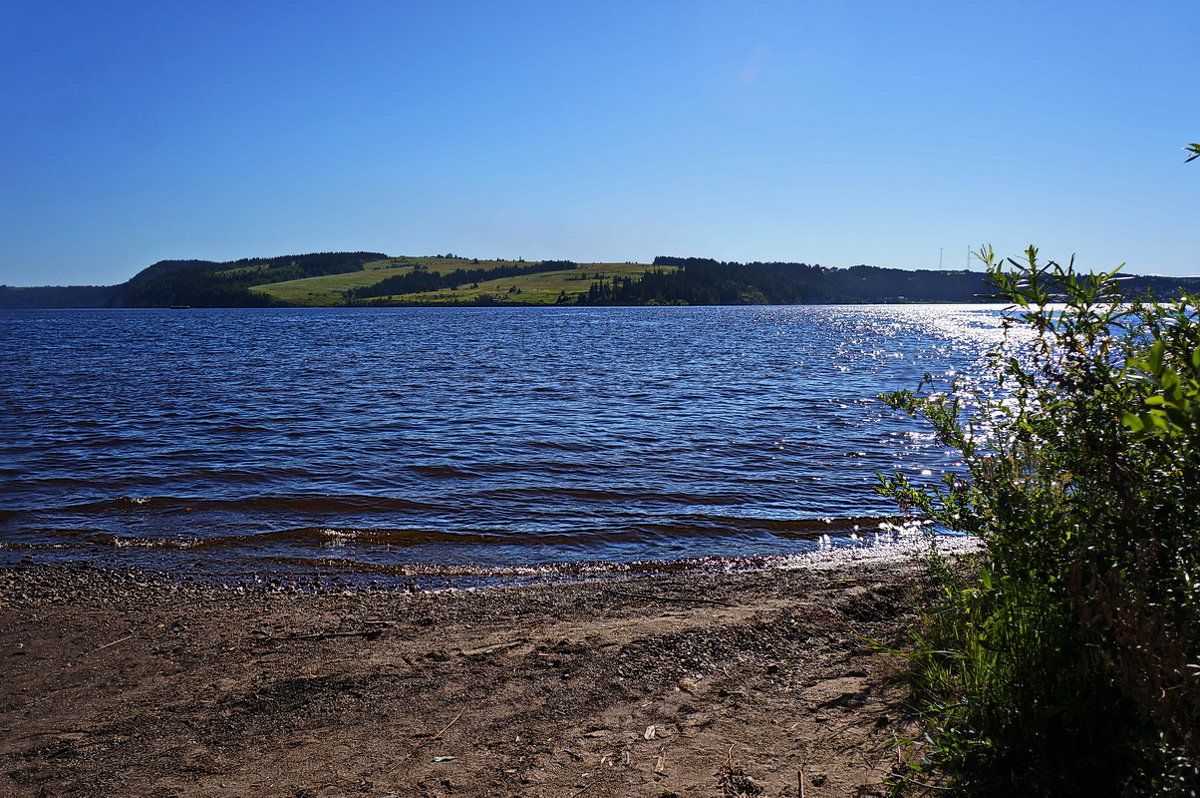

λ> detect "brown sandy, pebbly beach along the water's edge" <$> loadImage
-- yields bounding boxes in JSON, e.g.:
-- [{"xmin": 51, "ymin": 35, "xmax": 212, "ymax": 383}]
[{"xmin": 0, "ymin": 554, "xmax": 918, "ymax": 798}]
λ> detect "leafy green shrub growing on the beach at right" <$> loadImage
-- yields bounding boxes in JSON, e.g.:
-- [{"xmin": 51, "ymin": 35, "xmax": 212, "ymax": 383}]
[{"xmin": 880, "ymin": 247, "xmax": 1200, "ymax": 796}]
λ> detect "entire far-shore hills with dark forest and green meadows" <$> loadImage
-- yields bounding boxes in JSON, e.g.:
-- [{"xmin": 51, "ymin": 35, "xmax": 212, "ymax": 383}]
[{"xmin": 9, "ymin": 252, "xmax": 1200, "ymax": 308}]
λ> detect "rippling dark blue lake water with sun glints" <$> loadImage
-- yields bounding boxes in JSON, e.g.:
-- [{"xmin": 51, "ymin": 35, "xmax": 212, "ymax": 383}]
[{"xmin": 0, "ymin": 305, "xmax": 1001, "ymax": 580}]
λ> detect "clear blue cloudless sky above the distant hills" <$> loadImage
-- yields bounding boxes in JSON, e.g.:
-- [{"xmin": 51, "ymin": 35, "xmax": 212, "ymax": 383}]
[{"xmin": 0, "ymin": 0, "xmax": 1200, "ymax": 286}]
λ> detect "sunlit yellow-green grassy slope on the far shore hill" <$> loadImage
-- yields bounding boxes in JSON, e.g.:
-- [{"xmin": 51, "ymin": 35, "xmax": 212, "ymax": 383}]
[{"xmin": 253, "ymin": 257, "xmax": 650, "ymax": 306}]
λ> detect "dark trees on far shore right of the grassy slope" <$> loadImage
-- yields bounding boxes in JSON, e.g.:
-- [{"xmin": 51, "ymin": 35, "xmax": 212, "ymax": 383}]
[{"xmin": 566, "ymin": 257, "xmax": 1200, "ymax": 305}]
